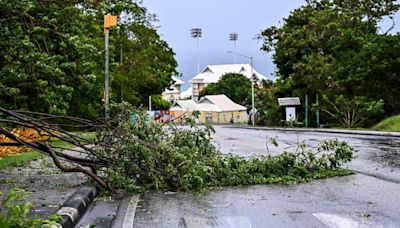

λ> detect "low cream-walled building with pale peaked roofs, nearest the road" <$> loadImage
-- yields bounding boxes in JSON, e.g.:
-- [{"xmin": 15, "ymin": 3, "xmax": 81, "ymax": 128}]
[{"xmin": 170, "ymin": 94, "xmax": 248, "ymax": 124}]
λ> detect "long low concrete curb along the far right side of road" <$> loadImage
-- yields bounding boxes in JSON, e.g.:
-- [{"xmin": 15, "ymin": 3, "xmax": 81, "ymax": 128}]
[{"xmin": 229, "ymin": 126, "xmax": 400, "ymax": 137}]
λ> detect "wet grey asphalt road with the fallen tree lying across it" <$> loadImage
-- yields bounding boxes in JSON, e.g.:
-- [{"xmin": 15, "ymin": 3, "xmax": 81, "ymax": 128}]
[{"xmin": 76, "ymin": 126, "xmax": 400, "ymax": 228}]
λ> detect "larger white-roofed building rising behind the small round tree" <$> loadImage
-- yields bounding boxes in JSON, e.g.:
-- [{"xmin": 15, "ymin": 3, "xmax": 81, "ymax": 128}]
[{"xmin": 188, "ymin": 64, "xmax": 267, "ymax": 101}]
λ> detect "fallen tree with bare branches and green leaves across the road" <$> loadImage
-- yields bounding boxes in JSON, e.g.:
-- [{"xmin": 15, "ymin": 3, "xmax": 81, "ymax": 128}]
[{"xmin": 0, "ymin": 104, "xmax": 355, "ymax": 192}]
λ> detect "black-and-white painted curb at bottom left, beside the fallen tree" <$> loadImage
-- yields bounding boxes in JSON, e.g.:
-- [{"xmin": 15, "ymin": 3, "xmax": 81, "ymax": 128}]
[{"xmin": 57, "ymin": 186, "xmax": 97, "ymax": 228}]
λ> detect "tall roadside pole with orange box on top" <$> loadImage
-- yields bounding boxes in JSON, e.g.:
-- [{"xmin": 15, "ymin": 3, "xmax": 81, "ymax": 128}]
[{"xmin": 104, "ymin": 15, "xmax": 117, "ymax": 120}]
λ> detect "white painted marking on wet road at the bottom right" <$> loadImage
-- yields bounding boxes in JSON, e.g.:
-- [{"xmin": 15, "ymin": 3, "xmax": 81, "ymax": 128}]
[{"xmin": 313, "ymin": 213, "xmax": 383, "ymax": 228}]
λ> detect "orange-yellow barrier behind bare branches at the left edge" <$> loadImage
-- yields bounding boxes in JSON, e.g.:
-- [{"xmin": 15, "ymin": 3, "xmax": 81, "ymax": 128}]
[{"xmin": 0, "ymin": 128, "xmax": 50, "ymax": 157}]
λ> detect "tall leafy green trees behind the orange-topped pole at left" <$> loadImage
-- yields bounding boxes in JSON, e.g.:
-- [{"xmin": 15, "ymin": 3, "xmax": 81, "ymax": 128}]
[{"xmin": 0, "ymin": 0, "xmax": 177, "ymax": 119}]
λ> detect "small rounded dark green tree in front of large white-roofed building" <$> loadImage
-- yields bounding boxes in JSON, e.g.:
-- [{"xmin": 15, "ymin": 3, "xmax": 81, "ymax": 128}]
[{"xmin": 199, "ymin": 73, "xmax": 251, "ymax": 109}]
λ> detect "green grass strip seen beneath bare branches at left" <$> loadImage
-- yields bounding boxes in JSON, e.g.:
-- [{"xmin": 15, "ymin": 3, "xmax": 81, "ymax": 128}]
[{"xmin": 0, "ymin": 132, "xmax": 95, "ymax": 170}]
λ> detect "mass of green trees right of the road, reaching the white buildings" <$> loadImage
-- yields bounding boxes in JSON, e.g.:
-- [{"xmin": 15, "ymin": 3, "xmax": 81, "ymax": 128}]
[{"xmin": 200, "ymin": 0, "xmax": 400, "ymax": 128}]
